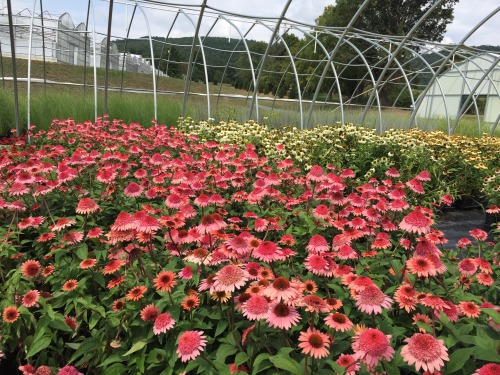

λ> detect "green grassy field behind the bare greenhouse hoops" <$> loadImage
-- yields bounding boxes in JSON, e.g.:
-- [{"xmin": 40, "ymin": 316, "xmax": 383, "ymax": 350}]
[{"xmin": 0, "ymin": 58, "xmax": 500, "ymax": 136}]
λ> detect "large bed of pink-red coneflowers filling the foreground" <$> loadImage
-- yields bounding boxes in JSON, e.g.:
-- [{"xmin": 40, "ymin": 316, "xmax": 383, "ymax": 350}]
[{"xmin": 0, "ymin": 120, "xmax": 500, "ymax": 374}]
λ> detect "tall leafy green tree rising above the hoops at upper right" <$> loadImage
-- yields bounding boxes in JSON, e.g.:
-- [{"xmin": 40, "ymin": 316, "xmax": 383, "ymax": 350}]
[{"xmin": 316, "ymin": 0, "xmax": 459, "ymax": 105}]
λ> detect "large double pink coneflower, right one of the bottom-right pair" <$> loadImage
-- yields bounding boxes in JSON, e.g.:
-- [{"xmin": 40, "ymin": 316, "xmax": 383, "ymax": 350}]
[{"xmin": 401, "ymin": 333, "xmax": 449, "ymax": 373}]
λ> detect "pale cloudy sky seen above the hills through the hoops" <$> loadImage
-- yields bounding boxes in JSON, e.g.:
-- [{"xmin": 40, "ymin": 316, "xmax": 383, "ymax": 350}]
[{"xmin": 0, "ymin": 0, "xmax": 500, "ymax": 45}]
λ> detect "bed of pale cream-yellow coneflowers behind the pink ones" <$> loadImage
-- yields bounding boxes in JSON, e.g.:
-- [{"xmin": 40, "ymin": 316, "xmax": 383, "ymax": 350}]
[{"xmin": 178, "ymin": 118, "xmax": 500, "ymax": 200}]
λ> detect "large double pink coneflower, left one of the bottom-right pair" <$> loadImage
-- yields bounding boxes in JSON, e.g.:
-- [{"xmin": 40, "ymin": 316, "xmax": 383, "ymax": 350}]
[{"xmin": 352, "ymin": 328, "xmax": 394, "ymax": 369}]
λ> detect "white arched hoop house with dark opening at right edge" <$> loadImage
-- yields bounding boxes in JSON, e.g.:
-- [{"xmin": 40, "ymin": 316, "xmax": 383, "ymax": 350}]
[{"xmin": 417, "ymin": 53, "xmax": 500, "ymax": 123}]
